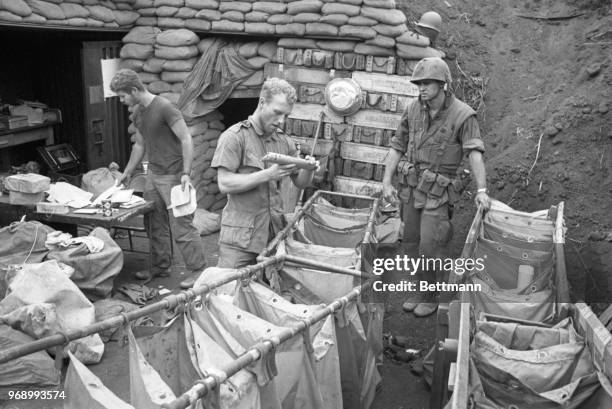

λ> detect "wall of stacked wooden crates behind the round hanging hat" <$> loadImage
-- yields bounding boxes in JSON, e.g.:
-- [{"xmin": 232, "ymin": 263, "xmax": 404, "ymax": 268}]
[{"xmin": 264, "ymin": 48, "xmax": 418, "ymax": 196}]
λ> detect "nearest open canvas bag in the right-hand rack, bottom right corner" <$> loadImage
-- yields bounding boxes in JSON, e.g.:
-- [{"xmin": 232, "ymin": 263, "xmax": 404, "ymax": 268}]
[{"xmin": 470, "ymin": 319, "xmax": 599, "ymax": 409}]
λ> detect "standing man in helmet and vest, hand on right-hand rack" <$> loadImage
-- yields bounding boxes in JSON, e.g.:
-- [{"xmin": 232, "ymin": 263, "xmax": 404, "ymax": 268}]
[{"xmin": 383, "ymin": 57, "xmax": 490, "ymax": 316}]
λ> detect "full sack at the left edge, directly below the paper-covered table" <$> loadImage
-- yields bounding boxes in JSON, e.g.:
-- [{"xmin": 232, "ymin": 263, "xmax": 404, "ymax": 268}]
[{"xmin": 0, "ymin": 221, "xmax": 55, "ymax": 268}]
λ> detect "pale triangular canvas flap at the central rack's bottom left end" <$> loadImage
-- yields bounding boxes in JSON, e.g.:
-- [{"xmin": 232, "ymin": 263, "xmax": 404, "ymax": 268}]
[{"xmin": 64, "ymin": 353, "xmax": 134, "ymax": 409}]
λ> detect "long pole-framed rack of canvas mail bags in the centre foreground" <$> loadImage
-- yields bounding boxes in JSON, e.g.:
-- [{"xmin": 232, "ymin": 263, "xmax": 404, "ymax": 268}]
[{"xmin": 0, "ymin": 192, "xmax": 392, "ymax": 409}]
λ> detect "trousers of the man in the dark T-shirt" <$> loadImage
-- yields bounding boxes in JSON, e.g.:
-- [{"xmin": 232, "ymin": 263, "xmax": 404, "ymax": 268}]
[{"xmin": 143, "ymin": 173, "xmax": 206, "ymax": 273}]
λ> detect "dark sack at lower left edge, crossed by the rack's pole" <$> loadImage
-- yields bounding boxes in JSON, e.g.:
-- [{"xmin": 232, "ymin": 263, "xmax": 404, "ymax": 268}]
[{"xmin": 0, "ymin": 325, "xmax": 61, "ymax": 394}]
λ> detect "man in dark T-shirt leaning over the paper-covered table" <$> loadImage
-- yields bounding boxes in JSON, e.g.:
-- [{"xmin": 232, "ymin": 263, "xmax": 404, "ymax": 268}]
[{"xmin": 111, "ymin": 70, "xmax": 206, "ymax": 288}]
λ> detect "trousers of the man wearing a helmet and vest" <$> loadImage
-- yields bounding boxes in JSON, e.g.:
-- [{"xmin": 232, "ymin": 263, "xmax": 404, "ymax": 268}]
[{"xmin": 400, "ymin": 188, "xmax": 453, "ymax": 293}]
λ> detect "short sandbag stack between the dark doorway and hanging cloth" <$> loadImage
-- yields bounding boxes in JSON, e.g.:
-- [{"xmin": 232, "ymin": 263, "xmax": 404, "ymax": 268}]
[{"xmin": 148, "ymin": 28, "xmax": 200, "ymax": 104}]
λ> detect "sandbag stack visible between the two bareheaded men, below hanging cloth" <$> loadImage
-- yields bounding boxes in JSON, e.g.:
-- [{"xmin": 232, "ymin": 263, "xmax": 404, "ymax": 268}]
[{"xmin": 187, "ymin": 111, "xmax": 227, "ymax": 211}]
